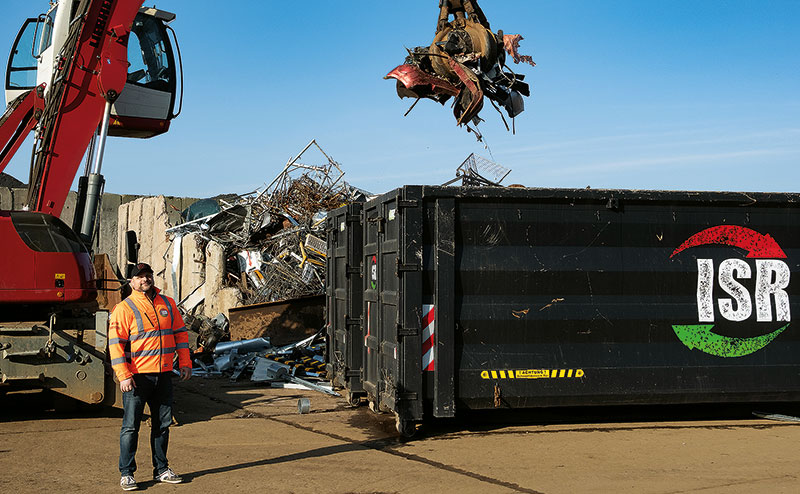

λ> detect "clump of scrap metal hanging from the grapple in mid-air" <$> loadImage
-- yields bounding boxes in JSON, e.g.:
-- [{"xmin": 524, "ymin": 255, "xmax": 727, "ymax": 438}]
[{"xmin": 385, "ymin": 0, "xmax": 536, "ymax": 131}]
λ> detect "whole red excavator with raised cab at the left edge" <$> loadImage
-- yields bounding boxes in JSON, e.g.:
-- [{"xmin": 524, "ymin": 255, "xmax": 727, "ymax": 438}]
[{"xmin": 0, "ymin": 0, "xmax": 182, "ymax": 404}]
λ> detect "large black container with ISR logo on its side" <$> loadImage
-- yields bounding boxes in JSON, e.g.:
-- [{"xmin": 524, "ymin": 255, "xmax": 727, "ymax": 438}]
[{"xmin": 363, "ymin": 186, "xmax": 800, "ymax": 428}]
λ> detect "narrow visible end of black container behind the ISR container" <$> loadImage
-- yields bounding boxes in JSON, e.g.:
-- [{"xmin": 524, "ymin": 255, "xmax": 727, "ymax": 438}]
[{"xmin": 325, "ymin": 203, "xmax": 364, "ymax": 402}]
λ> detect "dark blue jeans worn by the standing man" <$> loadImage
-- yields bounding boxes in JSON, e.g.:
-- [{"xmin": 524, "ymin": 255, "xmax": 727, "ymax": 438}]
[{"xmin": 119, "ymin": 372, "xmax": 172, "ymax": 476}]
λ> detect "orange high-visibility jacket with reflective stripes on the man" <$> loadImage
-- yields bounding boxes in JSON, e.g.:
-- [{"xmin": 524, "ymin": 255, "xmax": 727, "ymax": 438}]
[{"xmin": 108, "ymin": 288, "xmax": 192, "ymax": 381}]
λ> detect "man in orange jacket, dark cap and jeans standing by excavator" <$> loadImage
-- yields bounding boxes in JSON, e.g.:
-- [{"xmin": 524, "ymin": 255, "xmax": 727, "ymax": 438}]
[{"xmin": 108, "ymin": 263, "xmax": 192, "ymax": 491}]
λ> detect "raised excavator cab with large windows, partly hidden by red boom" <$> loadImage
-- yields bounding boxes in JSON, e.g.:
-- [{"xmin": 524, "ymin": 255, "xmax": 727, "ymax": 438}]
[{"xmin": 5, "ymin": 4, "xmax": 183, "ymax": 138}]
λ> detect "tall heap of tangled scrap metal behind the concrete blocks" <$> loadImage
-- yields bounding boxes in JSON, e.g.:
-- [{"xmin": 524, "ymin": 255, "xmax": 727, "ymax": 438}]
[{"xmin": 169, "ymin": 140, "xmax": 365, "ymax": 305}]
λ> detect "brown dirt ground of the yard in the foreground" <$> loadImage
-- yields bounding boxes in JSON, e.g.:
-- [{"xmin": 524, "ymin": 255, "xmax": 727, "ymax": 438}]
[{"xmin": 0, "ymin": 377, "xmax": 800, "ymax": 494}]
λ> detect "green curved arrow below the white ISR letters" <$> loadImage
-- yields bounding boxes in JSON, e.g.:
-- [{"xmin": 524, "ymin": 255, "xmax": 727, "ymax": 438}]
[{"xmin": 672, "ymin": 324, "xmax": 789, "ymax": 358}]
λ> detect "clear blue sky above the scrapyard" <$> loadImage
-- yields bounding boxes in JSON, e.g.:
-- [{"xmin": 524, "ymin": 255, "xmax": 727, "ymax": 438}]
[{"xmin": 0, "ymin": 0, "xmax": 800, "ymax": 197}]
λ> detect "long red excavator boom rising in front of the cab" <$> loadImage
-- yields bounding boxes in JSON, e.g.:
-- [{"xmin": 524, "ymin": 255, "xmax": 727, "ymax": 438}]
[{"xmin": 26, "ymin": 0, "xmax": 143, "ymax": 216}]
